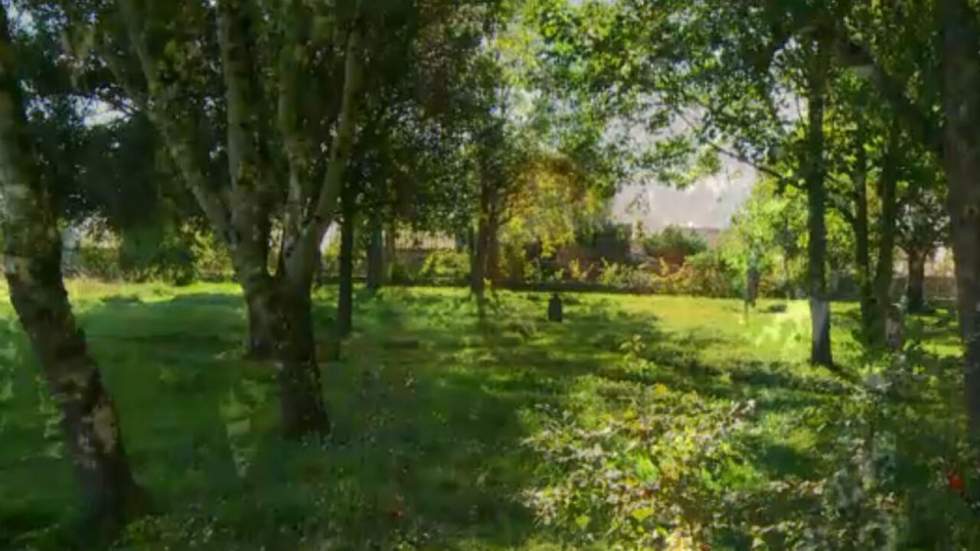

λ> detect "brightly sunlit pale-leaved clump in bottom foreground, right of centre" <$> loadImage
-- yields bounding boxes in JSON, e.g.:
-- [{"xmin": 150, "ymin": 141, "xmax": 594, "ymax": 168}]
[{"xmin": 526, "ymin": 384, "xmax": 753, "ymax": 549}]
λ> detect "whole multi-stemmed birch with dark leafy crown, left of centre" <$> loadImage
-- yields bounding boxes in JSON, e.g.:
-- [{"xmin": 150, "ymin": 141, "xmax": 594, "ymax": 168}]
[{"xmin": 46, "ymin": 0, "xmax": 498, "ymax": 437}]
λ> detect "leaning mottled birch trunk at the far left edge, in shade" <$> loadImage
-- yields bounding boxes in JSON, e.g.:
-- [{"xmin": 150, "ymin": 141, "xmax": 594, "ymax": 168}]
[{"xmin": 0, "ymin": 6, "xmax": 143, "ymax": 536}]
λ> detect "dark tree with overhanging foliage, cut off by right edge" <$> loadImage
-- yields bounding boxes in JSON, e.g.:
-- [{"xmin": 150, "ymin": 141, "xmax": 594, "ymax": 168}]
[{"xmin": 834, "ymin": 0, "xmax": 980, "ymax": 435}]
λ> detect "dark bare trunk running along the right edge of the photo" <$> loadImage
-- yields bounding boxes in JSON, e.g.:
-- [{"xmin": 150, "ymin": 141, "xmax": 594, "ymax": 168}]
[{"xmin": 941, "ymin": 0, "xmax": 980, "ymax": 437}]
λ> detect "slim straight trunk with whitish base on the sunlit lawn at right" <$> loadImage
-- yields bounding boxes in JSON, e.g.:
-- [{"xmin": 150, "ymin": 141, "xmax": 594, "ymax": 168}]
[{"xmin": 805, "ymin": 38, "xmax": 833, "ymax": 367}]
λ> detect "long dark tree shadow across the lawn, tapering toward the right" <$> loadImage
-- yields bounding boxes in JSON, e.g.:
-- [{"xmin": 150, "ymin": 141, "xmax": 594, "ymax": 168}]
[{"xmin": 0, "ymin": 289, "xmax": 856, "ymax": 550}]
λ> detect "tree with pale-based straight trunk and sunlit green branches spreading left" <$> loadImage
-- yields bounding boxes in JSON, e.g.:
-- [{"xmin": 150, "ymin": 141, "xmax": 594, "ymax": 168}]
[{"xmin": 524, "ymin": 0, "xmax": 852, "ymax": 366}]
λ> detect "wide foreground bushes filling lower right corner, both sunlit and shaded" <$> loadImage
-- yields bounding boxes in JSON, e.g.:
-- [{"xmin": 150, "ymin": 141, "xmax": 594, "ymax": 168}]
[{"xmin": 524, "ymin": 336, "xmax": 980, "ymax": 551}]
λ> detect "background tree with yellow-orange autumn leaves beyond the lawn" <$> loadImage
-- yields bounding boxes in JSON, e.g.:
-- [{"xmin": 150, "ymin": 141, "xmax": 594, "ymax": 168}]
[{"xmin": 468, "ymin": 2, "xmax": 631, "ymax": 297}]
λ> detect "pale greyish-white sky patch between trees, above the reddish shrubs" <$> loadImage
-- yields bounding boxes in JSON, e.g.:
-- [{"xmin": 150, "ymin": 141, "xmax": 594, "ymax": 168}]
[{"xmin": 613, "ymin": 160, "xmax": 756, "ymax": 232}]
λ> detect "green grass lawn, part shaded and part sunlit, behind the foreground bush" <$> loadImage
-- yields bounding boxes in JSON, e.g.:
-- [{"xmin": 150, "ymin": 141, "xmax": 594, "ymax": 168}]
[{"xmin": 0, "ymin": 282, "xmax": 956, "ymax": 550}]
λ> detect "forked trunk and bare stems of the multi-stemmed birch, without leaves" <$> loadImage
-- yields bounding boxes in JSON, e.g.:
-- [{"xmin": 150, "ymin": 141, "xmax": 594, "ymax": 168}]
[{"xmin": 116, "ymin": 0, "xmax": 363, "ymax": 437}]
